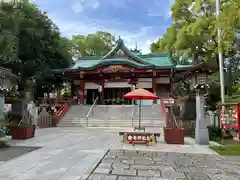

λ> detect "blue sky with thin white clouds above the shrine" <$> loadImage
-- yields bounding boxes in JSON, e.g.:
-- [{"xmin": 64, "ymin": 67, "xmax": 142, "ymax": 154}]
[{"xmin": 32, "ymin": 0, "xmax": 173, "ymax": 53}]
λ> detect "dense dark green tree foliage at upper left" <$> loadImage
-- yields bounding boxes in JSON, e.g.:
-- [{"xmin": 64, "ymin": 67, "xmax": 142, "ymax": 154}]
[{"xmin": 0, "ymin": 1, "xmax": 72, "ymax": 97}]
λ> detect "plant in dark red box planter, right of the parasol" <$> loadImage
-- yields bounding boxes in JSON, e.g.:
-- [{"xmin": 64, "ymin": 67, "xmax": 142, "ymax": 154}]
[{"xmin": 163, "ymin": 104, "xmax": 184, "ymax": 144}]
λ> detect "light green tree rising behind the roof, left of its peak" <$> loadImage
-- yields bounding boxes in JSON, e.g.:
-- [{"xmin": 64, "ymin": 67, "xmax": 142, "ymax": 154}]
[{"xmin": 72, "ymin": 31, "xmax": 115, "ymax": 56}]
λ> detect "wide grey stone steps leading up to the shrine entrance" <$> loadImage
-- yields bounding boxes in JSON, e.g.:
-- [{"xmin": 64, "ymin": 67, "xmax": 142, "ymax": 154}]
[{"xmin": 58, "ymin": 104, "xmax": 165, "ymax": 127}]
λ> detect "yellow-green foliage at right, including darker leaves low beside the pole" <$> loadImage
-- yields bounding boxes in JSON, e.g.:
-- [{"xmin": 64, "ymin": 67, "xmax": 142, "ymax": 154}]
[{"xmin": 151, "ymin": 0, "xmax": 240, "ymax": 105}]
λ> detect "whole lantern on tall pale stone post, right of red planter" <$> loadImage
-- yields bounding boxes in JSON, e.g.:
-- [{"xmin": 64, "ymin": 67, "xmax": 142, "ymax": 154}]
[{"xmin": 191, "ymin": 72, "xmax": 209, "ymax": 145}]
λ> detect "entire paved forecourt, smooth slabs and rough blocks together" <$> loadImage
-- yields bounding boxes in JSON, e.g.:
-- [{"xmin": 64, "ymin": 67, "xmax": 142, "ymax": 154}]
[{"xmin": 0, "ymin": 127, "xmax": 240, "ymax": 180}]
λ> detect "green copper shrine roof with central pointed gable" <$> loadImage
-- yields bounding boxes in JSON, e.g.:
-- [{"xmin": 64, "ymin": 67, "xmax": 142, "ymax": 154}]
[{"xmin": 54, "ymin": 39, "xmax": 197, "ymax": 72}]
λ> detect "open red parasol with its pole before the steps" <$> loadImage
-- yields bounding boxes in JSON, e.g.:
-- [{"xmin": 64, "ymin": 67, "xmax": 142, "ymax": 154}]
[{"xmin": 123, "ymin": 88, "xmax": 159, "ymax": 128}]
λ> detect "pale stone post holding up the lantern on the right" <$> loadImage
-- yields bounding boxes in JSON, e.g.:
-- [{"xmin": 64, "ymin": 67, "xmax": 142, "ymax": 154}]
[{"xmin": 195, "ymin": 89, "xmax": 209, "ymax": 145}]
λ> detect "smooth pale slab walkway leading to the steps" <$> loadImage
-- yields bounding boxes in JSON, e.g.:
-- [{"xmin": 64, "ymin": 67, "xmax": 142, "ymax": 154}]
[{"xmin": 0, "ymin": 128, "xmax": 117, "ymax": 180}]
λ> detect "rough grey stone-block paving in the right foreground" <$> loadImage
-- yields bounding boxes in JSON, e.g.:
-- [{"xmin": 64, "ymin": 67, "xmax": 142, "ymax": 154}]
[{"xmin": 88, "ymin": 150, "xmax": 240, "ymax": 180}]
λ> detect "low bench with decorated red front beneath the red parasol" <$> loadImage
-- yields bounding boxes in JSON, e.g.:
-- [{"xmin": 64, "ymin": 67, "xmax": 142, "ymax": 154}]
[{"xmin": 119, "ymin": 131, "xmax": 160, "ymax": 145}]
